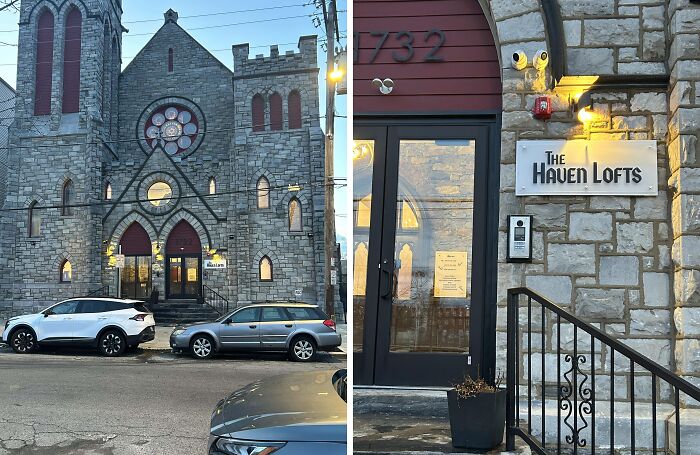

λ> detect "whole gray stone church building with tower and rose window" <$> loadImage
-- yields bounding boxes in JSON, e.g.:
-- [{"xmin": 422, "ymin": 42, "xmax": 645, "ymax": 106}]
[{"xmin": 0, "ymin": 0, "xmax": 324, "ymax": 313}]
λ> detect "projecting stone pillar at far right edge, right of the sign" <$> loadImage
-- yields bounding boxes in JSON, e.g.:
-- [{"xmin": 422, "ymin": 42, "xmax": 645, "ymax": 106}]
[{"xmin": 667, "ymin": 0, "xmax": 700, "ymax": 385}]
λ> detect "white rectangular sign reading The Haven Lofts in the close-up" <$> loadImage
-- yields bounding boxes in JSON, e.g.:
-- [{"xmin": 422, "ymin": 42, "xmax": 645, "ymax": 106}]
[{"xmin": 515, "ymin": 140, "xmax": 659, "ymax": 196}]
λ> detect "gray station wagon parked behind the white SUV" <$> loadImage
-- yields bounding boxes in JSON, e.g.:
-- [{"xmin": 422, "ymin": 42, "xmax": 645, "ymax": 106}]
[{"xmin": 170, "ymin": 302, "xmax": 341, "ymax": 362}]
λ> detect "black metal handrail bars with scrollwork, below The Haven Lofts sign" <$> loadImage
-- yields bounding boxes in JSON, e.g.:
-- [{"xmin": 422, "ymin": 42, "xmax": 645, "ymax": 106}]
[{"xmin": 506, "ymin": 287, "xmax": 700, "ymax": 455}]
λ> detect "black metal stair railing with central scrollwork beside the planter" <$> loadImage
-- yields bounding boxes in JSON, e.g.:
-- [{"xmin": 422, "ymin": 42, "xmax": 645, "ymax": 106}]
[{"xmin": 506, "ymin": 288, "xmax": 700, "ymax": 455}]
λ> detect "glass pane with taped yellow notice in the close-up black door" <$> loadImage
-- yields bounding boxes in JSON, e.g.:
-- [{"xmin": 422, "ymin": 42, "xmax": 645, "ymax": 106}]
[{"xmin": 390, "ymin": 140, "xmax": 475, "ymax": 352}]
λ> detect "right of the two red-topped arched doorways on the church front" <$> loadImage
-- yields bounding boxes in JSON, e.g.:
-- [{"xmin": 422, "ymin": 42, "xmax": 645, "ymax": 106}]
[{"xmin": 165, "ymin": 220, "xmax": 202, "ymax": 299}]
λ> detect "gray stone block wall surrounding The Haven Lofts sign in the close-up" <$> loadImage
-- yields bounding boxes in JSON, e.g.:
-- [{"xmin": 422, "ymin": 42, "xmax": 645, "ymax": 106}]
[{"xmin": 481, "ymin": 0, "xmax": 700, "ymax": 408}]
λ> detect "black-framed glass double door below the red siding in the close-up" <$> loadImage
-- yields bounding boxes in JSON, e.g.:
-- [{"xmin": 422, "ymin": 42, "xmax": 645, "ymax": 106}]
[{"xmin": 353, "ymin": 125, "xmax": 495, "ymax": 386}]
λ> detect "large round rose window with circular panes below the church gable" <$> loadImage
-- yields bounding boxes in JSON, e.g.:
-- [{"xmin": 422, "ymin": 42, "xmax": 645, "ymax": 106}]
[{"xmin": 144, "ymin": 106, "xmax": 199, "ymax": 155}]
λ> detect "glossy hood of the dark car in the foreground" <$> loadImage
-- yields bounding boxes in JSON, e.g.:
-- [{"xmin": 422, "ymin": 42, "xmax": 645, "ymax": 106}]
[{"xmin": 211, "ymin": 370, "xmax": 347, "ymax": 443}]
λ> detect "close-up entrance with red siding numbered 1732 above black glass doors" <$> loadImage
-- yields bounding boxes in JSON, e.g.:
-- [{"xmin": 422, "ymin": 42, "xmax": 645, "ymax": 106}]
[{"xmin": 352, "ymin": 0, "xmax": 502, "ymax": 386}]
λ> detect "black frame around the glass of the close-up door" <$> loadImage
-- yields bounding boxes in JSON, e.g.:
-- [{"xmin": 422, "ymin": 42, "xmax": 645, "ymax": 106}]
[{"xmin": 354, "ymin": 116, "xmax": 501, "ymax": 385}]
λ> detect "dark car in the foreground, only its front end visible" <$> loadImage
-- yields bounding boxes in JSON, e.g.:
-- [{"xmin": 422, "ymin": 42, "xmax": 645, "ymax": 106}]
[{"xmin": 209, "ymin": 369, "xmax": 348, "ymax": 455}]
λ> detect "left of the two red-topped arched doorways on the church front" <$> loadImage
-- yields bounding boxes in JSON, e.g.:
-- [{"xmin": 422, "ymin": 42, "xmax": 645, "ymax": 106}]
[{"xmin": 119, "ymin": 222, "xmax": 151, "ymax": 299}]
